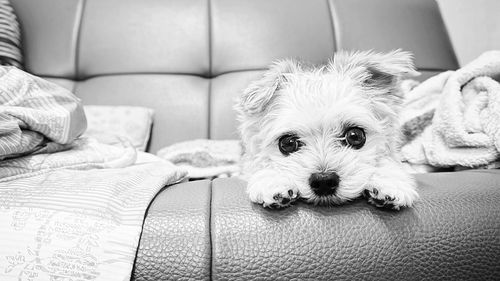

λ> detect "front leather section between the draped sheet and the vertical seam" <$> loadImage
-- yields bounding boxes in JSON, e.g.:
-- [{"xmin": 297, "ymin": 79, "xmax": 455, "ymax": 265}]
[{"xmin": 132, "ymin": 181, "xmax": 211, "ymax": 281}]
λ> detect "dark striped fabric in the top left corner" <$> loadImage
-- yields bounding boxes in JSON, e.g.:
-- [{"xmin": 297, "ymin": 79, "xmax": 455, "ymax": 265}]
[{"xmin": 0, "ymin": 0, "xmax": 23, "ymax": 68}]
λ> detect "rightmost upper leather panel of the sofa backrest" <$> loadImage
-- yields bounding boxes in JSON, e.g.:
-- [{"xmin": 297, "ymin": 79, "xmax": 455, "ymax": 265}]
[{"xmin": 329, "ymin": 0, "xmax": 458, "ymax": 70}]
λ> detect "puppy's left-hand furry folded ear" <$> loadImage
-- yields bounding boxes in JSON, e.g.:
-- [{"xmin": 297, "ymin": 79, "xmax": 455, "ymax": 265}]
[{"xmin": 236, "ymin": 59, "xmax": 301, "ymax": 116}]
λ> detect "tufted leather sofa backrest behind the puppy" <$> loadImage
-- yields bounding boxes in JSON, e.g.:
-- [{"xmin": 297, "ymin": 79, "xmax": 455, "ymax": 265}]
[{"xmin": 11, "ymin": 0, "xmax": 457, "ymax": 152}]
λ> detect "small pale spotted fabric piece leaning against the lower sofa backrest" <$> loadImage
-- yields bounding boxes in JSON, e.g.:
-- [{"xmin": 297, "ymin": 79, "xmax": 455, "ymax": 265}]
[{"xmin": 83, "ymin": 105, "xmax": 154, "ymax": 151}]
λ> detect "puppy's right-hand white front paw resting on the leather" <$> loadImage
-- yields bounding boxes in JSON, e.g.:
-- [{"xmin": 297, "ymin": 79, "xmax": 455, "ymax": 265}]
[{"xmin": 365, "ymin": 174, "xmax": 418, "ymax": 210}]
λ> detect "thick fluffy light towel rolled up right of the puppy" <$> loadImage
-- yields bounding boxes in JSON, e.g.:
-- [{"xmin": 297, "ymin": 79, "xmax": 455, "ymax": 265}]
[{"xmin": 401, "ymin": 51, "xmax": 500, "ymax": 168}]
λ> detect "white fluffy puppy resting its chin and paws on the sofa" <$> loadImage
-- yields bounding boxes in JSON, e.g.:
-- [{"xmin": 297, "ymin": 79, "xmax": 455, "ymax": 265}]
[{"xmin": 236, "ymin": 50, "xmax": 418, "ymax": 209}]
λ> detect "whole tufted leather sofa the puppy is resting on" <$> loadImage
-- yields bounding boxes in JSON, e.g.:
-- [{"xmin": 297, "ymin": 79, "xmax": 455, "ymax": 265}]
[{"xmin": 11, "ymin": 0, "xmax": 500, "ymax": 280}]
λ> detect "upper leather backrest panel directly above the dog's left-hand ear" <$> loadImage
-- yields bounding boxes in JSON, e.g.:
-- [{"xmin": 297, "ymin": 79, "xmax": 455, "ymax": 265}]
[{"xmin": 211, "ymin": 0, "xmax": 335, "ymax": 75}]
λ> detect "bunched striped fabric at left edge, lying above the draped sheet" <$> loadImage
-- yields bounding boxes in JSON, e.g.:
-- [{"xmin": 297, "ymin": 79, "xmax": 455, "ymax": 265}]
[{"xmin": 0, "ymin": 66, "xmax": 87, "ymax": 160}]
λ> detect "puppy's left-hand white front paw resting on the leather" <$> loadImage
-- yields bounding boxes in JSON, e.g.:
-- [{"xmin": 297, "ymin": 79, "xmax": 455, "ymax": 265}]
[{"xmin": 247, "ymin": 174, "xmax": 300, "ymax": 209}]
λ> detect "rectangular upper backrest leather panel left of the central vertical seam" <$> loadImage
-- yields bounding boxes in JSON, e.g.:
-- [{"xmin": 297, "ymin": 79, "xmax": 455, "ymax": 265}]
[{"xmin": 79, "ymin": 0, "xmax": 209, "ymax": 78}]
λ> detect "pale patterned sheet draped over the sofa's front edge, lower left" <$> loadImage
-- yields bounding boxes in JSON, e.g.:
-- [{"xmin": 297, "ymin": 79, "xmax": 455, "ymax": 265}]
[{"xmin": 0, "ymin": 139, "xmax": 185, "ymax": 281}]
